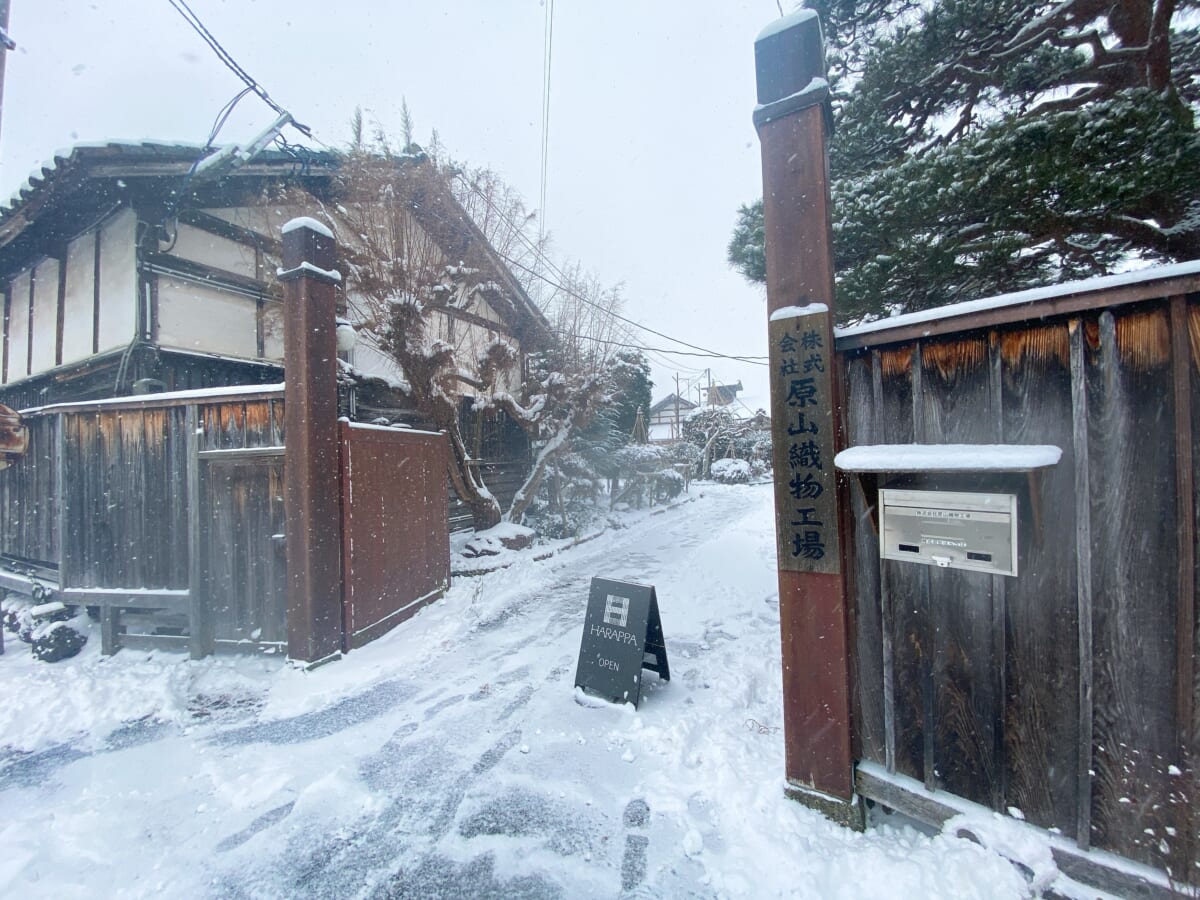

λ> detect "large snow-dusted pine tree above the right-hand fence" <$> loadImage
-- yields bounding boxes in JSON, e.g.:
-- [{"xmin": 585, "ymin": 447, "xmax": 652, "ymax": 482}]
[{"xmin": 728, "ymin": 0, "xmax": 1200, "ymax": 320}]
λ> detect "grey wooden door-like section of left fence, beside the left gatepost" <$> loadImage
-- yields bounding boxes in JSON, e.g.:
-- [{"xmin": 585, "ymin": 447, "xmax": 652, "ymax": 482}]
[{"xmin": 200, "ymin": 456, "xmax": 288, "ymax": 646}]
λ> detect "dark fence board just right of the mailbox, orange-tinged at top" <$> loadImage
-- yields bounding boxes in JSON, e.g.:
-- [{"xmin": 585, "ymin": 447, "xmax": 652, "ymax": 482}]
[{"xmin": 997, "ymin": 323, "xmax": 1080, "ymax": 834}]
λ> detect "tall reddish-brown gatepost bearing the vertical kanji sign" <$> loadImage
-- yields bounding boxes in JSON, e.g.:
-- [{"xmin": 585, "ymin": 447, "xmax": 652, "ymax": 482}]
[{"xmin": 754, "ymin": 10, "xmax": 863, "ymax": 828}]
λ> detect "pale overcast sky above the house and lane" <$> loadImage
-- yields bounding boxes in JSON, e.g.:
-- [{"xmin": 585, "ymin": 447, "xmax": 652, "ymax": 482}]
[{"xmin": 0, "ymin": 0, "xmax": 796, "ymax": 412}]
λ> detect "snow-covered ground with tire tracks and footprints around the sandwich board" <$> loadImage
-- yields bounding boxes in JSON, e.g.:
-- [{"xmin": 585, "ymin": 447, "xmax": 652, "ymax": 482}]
[{"xmin": 0, "ymin": 485, "xmax": 1084, "ymax": 900}]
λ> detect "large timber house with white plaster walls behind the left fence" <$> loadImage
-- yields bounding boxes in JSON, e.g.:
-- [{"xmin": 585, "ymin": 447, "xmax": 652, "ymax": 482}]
[{"xmin": 0, "ymin": 143, "xmax": 548, "ymax": 520}]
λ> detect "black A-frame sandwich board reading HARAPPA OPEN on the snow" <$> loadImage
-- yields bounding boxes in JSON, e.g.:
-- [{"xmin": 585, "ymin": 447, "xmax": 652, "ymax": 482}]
[{"xmin": 575, "ymin": 578, "xmax": 671, "ymax": 707}]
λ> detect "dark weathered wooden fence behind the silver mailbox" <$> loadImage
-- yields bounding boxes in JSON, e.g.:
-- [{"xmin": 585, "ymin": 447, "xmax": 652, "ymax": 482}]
[{"xmin": 838, "ymin": 266, "xmax": 1200, "ymax": 890}]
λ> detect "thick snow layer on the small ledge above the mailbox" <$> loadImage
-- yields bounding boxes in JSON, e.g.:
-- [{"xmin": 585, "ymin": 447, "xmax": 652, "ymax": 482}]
[{"xmin": 833, "ymin": 444, "xmax": 1062, "ymax": 472}]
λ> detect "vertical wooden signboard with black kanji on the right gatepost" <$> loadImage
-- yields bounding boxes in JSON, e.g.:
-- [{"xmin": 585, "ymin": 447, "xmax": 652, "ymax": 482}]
[{"xmin": 768, "ymin": 304, "xmax": 841, "ymax": 575}]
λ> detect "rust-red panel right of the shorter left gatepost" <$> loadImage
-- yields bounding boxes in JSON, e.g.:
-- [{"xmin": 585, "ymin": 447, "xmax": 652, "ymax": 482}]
[{"xmin": 338, "ymin": 421, "xmax": 450, "ymax": 650}]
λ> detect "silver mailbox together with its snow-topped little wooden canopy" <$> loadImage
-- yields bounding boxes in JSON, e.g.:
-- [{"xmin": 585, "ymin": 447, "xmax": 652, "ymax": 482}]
[{"xmin": 834, "ymin": 444, "xmax": 1062, "ymax": 575}]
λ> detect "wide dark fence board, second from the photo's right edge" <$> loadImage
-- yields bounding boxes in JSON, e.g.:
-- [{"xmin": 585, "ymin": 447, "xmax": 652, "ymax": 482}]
[{"xmin": 1088, "ymin": 307, "xmax": 1181, "ymax": 870}]
